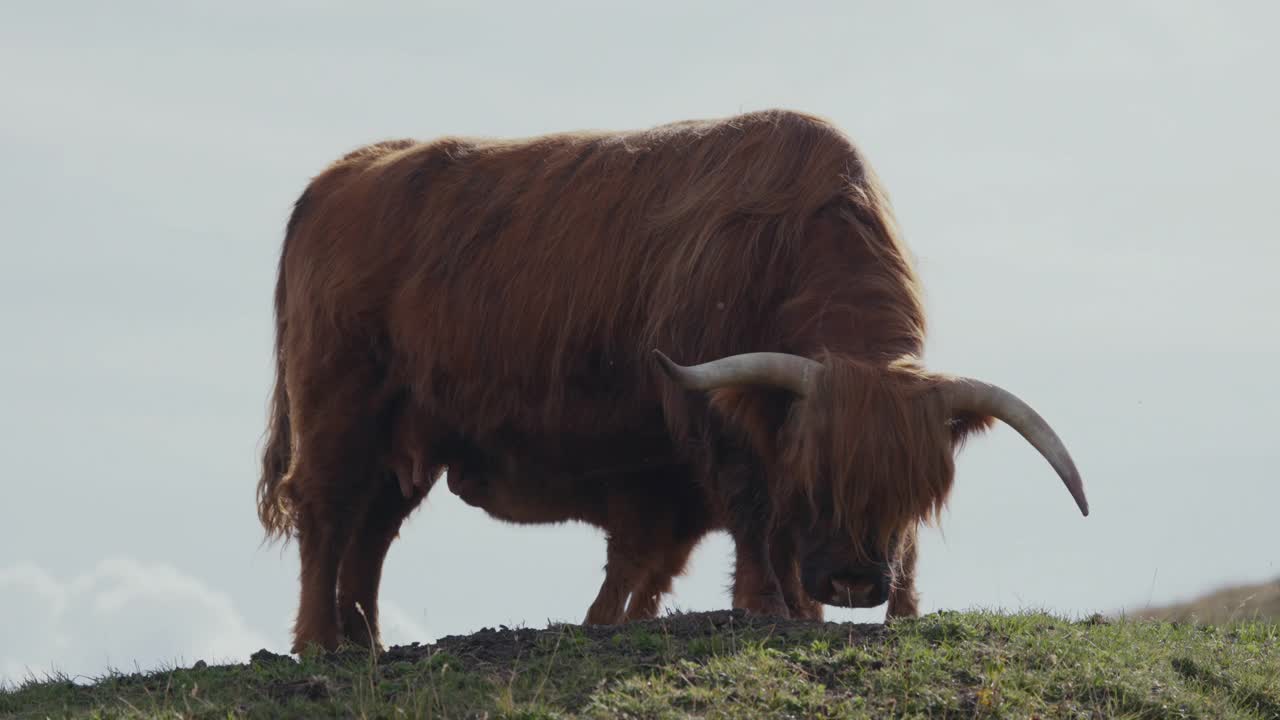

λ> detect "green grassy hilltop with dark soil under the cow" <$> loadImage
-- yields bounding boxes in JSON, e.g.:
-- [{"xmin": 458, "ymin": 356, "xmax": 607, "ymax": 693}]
[{"xmin": 0, "ymin": 611, "xmax": 1280, "ymax": 720}]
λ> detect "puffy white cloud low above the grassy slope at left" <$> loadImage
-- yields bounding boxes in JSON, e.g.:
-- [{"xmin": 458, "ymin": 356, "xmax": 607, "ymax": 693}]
[{"xmin": 0, "ymin": 556, "xmax": 268, "ymax": 684}]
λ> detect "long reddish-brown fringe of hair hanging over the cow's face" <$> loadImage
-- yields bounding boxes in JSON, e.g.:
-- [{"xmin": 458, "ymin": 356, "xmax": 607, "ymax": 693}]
[{"xmin": 778, "ymin": 355, "xmax": 991, "ymax": 559}]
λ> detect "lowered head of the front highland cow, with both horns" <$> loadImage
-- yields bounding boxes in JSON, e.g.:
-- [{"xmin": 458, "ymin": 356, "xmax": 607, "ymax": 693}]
[{"xmin": 655, "ymin": 351, "xmax": 1089, "ymax": 607}]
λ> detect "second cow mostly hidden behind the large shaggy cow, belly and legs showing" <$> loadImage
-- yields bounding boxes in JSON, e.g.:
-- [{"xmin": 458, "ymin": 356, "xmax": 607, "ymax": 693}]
[{"xmin": 388, "ymin": 397, "xmax": 823, "ymax": 625}]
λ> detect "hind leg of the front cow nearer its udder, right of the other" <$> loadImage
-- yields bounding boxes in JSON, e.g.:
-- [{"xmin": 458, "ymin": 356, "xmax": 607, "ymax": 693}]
[{"xmin": 338, "ymin": 471, "xmax": 439, "ymax": 648}]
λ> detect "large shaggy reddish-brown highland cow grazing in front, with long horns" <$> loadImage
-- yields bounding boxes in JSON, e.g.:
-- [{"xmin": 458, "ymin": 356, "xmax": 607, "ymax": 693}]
[{"xmin": 257, "ymin": 110, "xmax": 1088, "ymax": 651}]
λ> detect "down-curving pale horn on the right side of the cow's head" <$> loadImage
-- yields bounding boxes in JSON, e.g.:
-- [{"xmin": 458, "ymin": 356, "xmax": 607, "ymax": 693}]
[{"xmin": 942, "ymin": 378, "xmax": 1089, "ymax": 516}]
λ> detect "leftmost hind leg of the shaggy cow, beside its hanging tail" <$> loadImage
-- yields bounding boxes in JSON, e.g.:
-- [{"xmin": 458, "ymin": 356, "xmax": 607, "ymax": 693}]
[{"xmin": 283, "ymin": 348, "xmax": 398, "ymax": 652}]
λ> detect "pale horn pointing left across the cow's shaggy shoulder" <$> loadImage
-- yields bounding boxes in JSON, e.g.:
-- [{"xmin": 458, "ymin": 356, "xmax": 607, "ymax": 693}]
[{"xmin": 653, "ymin": 350, "xmax": 822, "ymax": 396}]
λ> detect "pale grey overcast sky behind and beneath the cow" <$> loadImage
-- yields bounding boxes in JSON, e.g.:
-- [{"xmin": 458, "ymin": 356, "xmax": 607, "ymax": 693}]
[{"xmin": 0, "ymin": 0, "xmax": 1280, "ymax": 682}]
